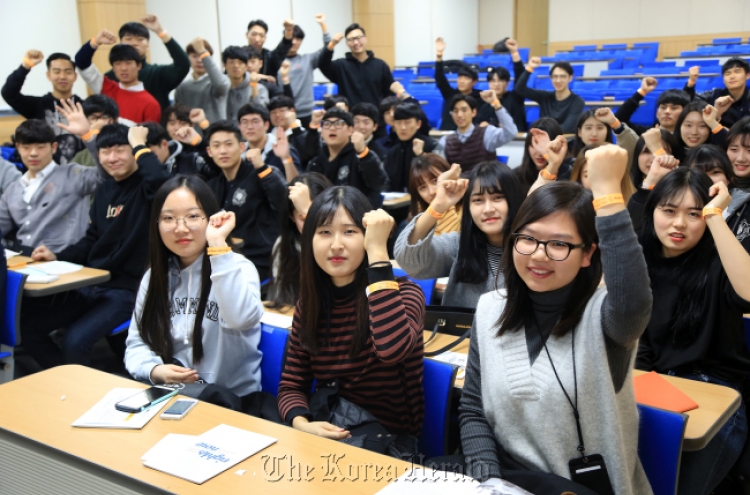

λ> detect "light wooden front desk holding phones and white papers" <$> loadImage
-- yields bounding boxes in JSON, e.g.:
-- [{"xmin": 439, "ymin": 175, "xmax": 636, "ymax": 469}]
[{"xmin": 0, "ymin": 366, "xmax": 411, "ymax": 495}]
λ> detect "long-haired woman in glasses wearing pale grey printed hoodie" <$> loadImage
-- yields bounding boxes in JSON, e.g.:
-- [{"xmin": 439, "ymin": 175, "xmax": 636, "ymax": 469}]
[{"xmin": 125, "ymin": 175, "xmax": 263, "ymax": 397}]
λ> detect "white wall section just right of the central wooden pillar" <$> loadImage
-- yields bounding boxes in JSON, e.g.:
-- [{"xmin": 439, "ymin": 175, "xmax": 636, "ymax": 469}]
[{"xmin": 393, "ymin": 0, "xmax": 479, "ymax": 66}]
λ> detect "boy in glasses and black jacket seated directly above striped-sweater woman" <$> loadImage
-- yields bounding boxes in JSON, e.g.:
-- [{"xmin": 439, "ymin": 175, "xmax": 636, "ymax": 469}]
[{"xmin": 307, "ymin": 108, "xmax": 388, "ymax": 208}]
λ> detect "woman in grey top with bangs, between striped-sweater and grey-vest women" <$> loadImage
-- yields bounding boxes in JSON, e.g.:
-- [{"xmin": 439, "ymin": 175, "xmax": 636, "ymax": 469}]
[{"xmin": 394, "ymin": 162, "xmax": 524, "ymax": 308}]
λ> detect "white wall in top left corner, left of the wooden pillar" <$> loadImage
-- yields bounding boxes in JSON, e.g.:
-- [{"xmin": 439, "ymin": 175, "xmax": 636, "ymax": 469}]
[{"xmin": 0, "ymin": 0, "xmax": 86, "ymax": 110}]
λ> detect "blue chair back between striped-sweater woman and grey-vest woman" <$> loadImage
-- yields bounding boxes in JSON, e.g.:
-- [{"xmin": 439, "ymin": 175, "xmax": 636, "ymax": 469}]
[{"xmin": 419, "ymin": 359, "xmax": 458, "ymax": 458}]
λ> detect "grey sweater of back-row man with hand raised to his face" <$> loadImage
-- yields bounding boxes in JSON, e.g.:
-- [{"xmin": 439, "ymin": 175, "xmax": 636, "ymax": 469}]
[{"xmin": 174, "ymin": 56, "xmax": 230, "ymax": 122}]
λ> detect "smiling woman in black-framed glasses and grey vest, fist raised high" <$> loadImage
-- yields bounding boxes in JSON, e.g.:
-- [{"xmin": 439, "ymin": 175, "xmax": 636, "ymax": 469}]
[{"xmin": 459, "ymin": 145, "xmax": 652, "ymax": 495}]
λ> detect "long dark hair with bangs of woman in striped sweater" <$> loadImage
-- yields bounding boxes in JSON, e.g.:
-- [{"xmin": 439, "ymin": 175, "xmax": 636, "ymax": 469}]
[{"xmin": 299, "ymin": 186, "xmax": 372, "ymax": 356}]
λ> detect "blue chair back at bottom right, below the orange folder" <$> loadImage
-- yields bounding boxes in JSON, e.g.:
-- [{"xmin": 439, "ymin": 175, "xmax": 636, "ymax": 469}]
[{"xmin": 638, "ymin": 404, "xmax": 688, "ymax": 495}]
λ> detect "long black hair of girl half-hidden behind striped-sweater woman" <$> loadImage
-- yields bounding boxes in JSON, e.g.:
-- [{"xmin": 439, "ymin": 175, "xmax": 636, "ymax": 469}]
[{"xmin": 268, "ymin": 172, "xmax": 333, "ymax": 306}]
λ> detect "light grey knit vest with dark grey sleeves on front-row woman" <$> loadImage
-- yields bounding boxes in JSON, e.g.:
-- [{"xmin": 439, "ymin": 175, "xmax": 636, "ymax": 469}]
[{"xmin": 459, "ymin": 211, "xmax": 652, "ymax": 495}]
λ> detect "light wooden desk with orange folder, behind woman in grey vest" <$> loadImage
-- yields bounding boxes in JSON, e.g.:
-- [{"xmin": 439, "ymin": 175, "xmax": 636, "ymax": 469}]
[{"xmin": 424, "ymin": 330, "xmax": 741, "ymax": 451}]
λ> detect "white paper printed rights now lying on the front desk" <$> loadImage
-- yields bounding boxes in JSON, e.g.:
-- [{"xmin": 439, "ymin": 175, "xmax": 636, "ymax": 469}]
[{"xmin": 143, "ymin": 425, "xmax": 276, "ymax": 485}]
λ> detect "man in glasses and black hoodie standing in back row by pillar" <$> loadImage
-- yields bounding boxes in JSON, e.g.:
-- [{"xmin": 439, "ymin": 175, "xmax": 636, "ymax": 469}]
[{"xmin": 319, "ymin": 23, "xmax": 393, "ymax": 106}]
